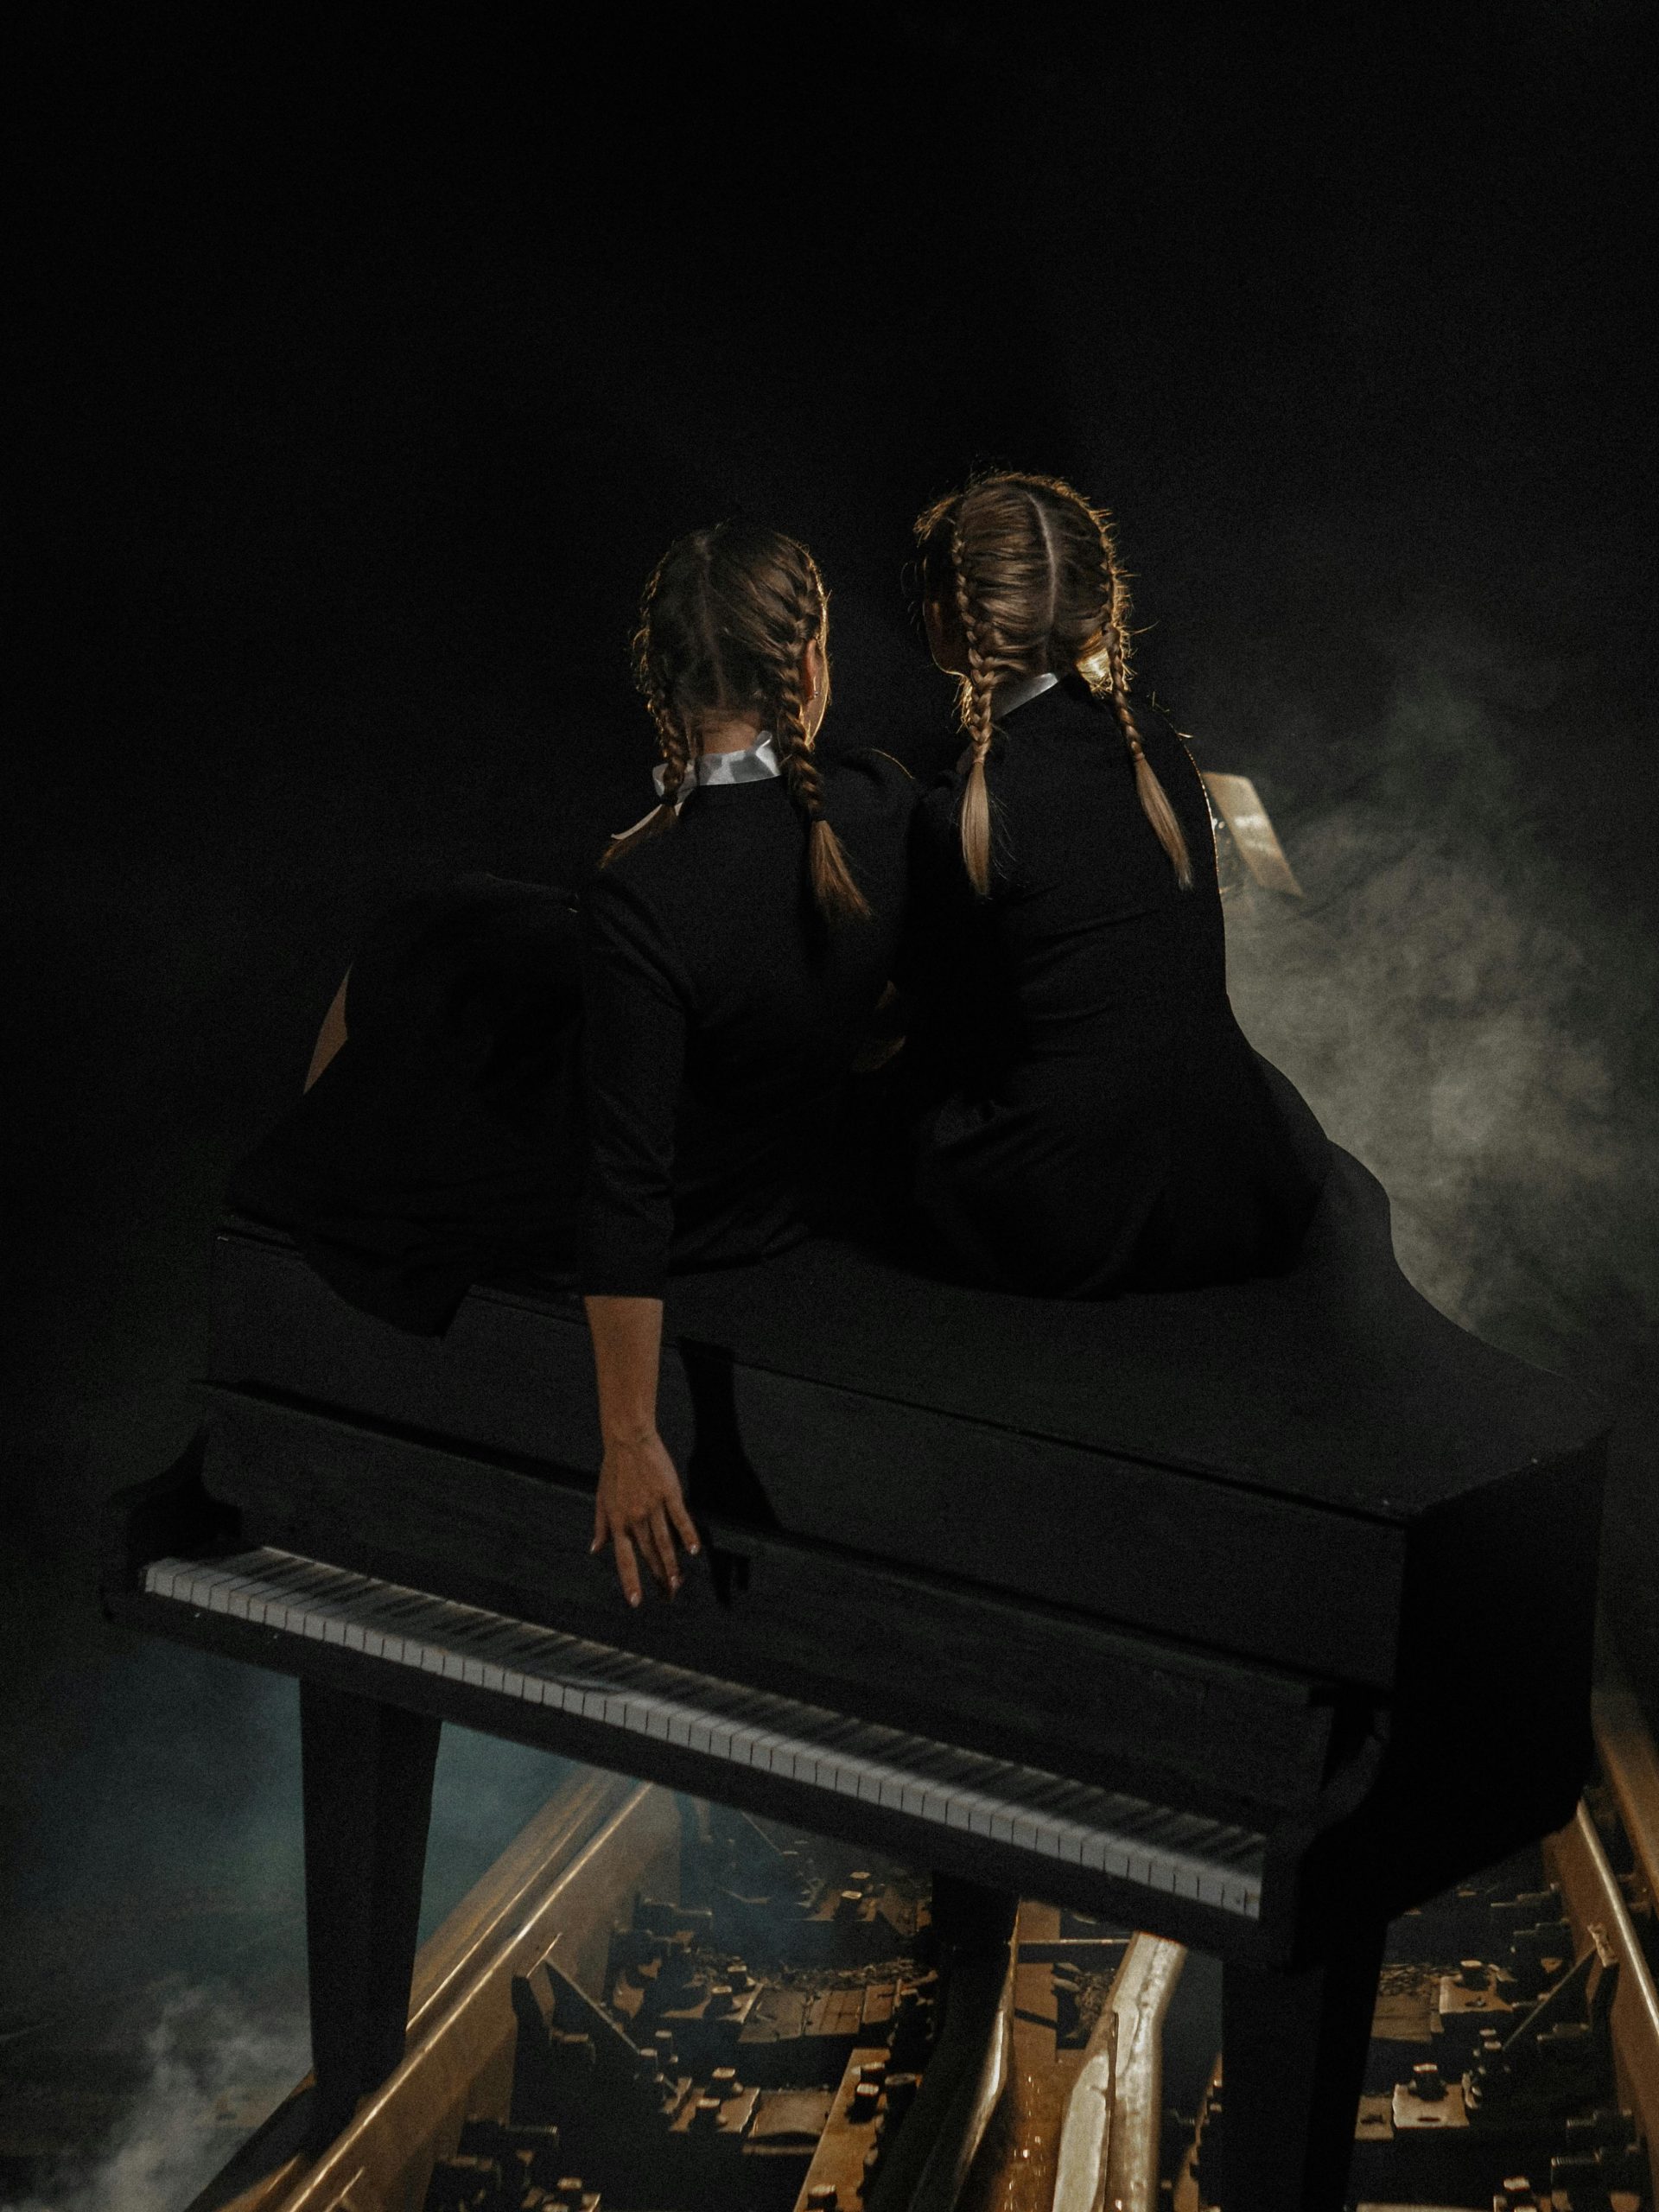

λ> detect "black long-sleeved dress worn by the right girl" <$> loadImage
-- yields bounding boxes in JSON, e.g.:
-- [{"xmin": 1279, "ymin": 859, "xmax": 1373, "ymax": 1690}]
[{"xmin": 902, "ymin": 677, "xmax": 1327, "ymax": 1296}]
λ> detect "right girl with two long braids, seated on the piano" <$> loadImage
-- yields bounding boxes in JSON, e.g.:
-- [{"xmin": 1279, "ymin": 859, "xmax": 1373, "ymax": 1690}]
[{"xmin": 905, "ymin": 471, "xmax": 1327, "ymax": 1296}]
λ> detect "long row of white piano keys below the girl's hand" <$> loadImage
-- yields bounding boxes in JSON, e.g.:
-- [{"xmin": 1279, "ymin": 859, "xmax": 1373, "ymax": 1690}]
[{"xmin": 143, "ymin": 1546, "xmax": 1265, "ymax": 1920}]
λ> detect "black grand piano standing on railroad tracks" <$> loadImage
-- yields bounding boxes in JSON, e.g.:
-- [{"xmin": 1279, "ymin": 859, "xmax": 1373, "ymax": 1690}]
[{"xmin": 104, "ymin": 1154, "xmax": 1606, "ymax": 2212}]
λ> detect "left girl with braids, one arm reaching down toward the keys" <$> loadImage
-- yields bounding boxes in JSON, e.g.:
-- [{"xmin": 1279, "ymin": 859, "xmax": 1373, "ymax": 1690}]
[{"xmin": 232, "ymin": 522, "xmax": 913, "ymax": 1604}]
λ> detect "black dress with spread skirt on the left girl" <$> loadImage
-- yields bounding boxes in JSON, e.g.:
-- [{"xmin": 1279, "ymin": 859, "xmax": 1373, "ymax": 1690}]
[{"xmin": 230, "ymin": 752, "xmax": 916, "ymax": 1334}]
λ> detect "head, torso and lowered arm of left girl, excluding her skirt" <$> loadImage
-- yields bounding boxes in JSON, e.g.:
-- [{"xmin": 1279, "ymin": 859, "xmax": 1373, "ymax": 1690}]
[{"xmin": 582, "ymin": 522, "xmax": 913, "ymax": 1601}]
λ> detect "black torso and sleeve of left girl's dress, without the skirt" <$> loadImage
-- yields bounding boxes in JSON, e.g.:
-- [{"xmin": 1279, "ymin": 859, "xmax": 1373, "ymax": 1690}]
[{"xmin": 584, "ymin": 752, "xmax": 913, "ymax": 1289}]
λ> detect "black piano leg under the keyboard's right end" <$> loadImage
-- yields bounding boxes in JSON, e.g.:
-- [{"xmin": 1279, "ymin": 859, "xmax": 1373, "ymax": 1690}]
[{"xmin": 1217, "ymin": 1923, "xmax": 1387, "ymax": 2212}]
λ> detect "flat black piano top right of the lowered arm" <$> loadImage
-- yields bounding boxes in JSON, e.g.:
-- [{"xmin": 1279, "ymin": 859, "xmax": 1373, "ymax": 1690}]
[{"xmin": 668, "ymin": 1150, "xmax": 1611, "ymax": 1520}]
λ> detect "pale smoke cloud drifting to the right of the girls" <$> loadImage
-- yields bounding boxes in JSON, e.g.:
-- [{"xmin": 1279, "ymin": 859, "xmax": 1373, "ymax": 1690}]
[{"xmin": 1199, "ymin": 628, "xmax": 1659, "ymax": 1356}]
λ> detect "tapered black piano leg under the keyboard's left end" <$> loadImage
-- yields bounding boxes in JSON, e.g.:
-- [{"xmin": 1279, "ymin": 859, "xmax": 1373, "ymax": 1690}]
[{"xmin": 299, "ymin": 1681, "xmax": 440, "ymax": 2139}]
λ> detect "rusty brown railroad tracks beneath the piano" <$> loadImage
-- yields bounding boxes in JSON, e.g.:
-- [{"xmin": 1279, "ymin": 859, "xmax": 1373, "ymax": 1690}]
[{"xmin": 188, "ymin": 1666, "xmax": 1659, "ymax": 2212}]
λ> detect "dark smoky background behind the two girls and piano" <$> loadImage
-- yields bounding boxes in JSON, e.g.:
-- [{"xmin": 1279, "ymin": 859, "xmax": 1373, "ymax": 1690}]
[{"xmin": 0, "ymin": 0, "xmax": 1659, "ymax": 2205}]
